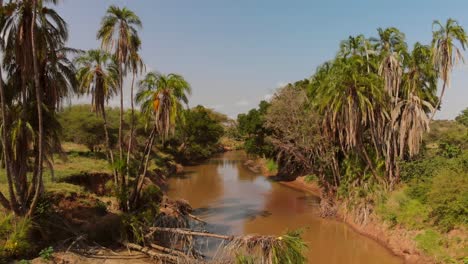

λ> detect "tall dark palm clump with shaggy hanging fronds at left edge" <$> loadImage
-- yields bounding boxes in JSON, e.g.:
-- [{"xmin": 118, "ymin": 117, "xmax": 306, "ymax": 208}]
[{"xmin": 0, "ymin": 0, "xmax": 74, "ymax": 214}]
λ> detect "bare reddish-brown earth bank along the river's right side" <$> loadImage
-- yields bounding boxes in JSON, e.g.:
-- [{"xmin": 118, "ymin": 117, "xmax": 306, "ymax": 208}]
[{"xmin": 244, "ymin": 158, "xmax": 436, "ymax": 264}]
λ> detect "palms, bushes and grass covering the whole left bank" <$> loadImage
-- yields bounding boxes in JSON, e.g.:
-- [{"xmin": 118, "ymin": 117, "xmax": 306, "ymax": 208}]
[{"xmin": 0, "ymin": 0, "xmax": 303, "ymax": 263}]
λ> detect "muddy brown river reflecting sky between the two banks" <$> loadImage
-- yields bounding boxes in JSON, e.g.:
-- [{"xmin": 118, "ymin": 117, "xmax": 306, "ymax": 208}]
[{"xmin": 169, "ymin": 151, "xmax": 403, "ymax": 264}]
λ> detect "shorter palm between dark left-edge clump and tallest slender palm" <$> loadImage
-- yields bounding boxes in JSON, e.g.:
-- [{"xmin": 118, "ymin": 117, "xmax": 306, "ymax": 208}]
[{"xmin": 76, "ymin": 50, "xmax": 118, "ymax": 186}]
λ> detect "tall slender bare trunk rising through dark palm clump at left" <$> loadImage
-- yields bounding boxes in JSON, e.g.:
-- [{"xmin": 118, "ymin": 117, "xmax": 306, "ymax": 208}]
[{"xmin": 28, "ymin": 0, "xmax": 44, "ymax": 216}]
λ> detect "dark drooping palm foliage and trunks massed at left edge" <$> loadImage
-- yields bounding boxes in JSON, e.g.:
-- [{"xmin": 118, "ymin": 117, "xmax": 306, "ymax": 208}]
[{"xmin": 0, "ymin": 1, "xmax": 77, "ymax": 216}]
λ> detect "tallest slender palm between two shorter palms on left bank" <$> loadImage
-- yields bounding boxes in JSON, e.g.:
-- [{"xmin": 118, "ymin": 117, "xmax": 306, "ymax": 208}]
[{"xmin": 97, "ymin": 5, "xmax": 142, "ymax": 187}]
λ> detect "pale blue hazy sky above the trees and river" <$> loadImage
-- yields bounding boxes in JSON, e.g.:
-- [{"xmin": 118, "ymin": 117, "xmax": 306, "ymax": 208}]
[{"xmin": 56, "ymin": 0, "xmax": 468, "ymax": 119}]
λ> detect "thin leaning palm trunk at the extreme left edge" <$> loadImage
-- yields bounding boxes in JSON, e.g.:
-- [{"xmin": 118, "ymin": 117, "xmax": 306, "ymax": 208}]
[{"xmin": 0, "ymin": 50, "xmax": 18, "ymax": 214}]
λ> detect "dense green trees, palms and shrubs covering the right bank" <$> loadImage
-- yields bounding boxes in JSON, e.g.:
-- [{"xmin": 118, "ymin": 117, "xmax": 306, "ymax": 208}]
[{"xmin": 237, "ymin": 19, "xmax": 468, "ymax": 263}]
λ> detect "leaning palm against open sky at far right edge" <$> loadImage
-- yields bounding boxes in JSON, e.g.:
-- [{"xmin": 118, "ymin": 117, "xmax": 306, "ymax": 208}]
[{"xmin": 431, "ymin": 18, "xmax": 468, "ymax": 119}]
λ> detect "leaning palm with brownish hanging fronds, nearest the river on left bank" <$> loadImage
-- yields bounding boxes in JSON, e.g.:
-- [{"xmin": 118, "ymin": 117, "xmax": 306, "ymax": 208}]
[{"xmin": 132, "ymin": 72, "xmax": 191, "ymax": 206}]
